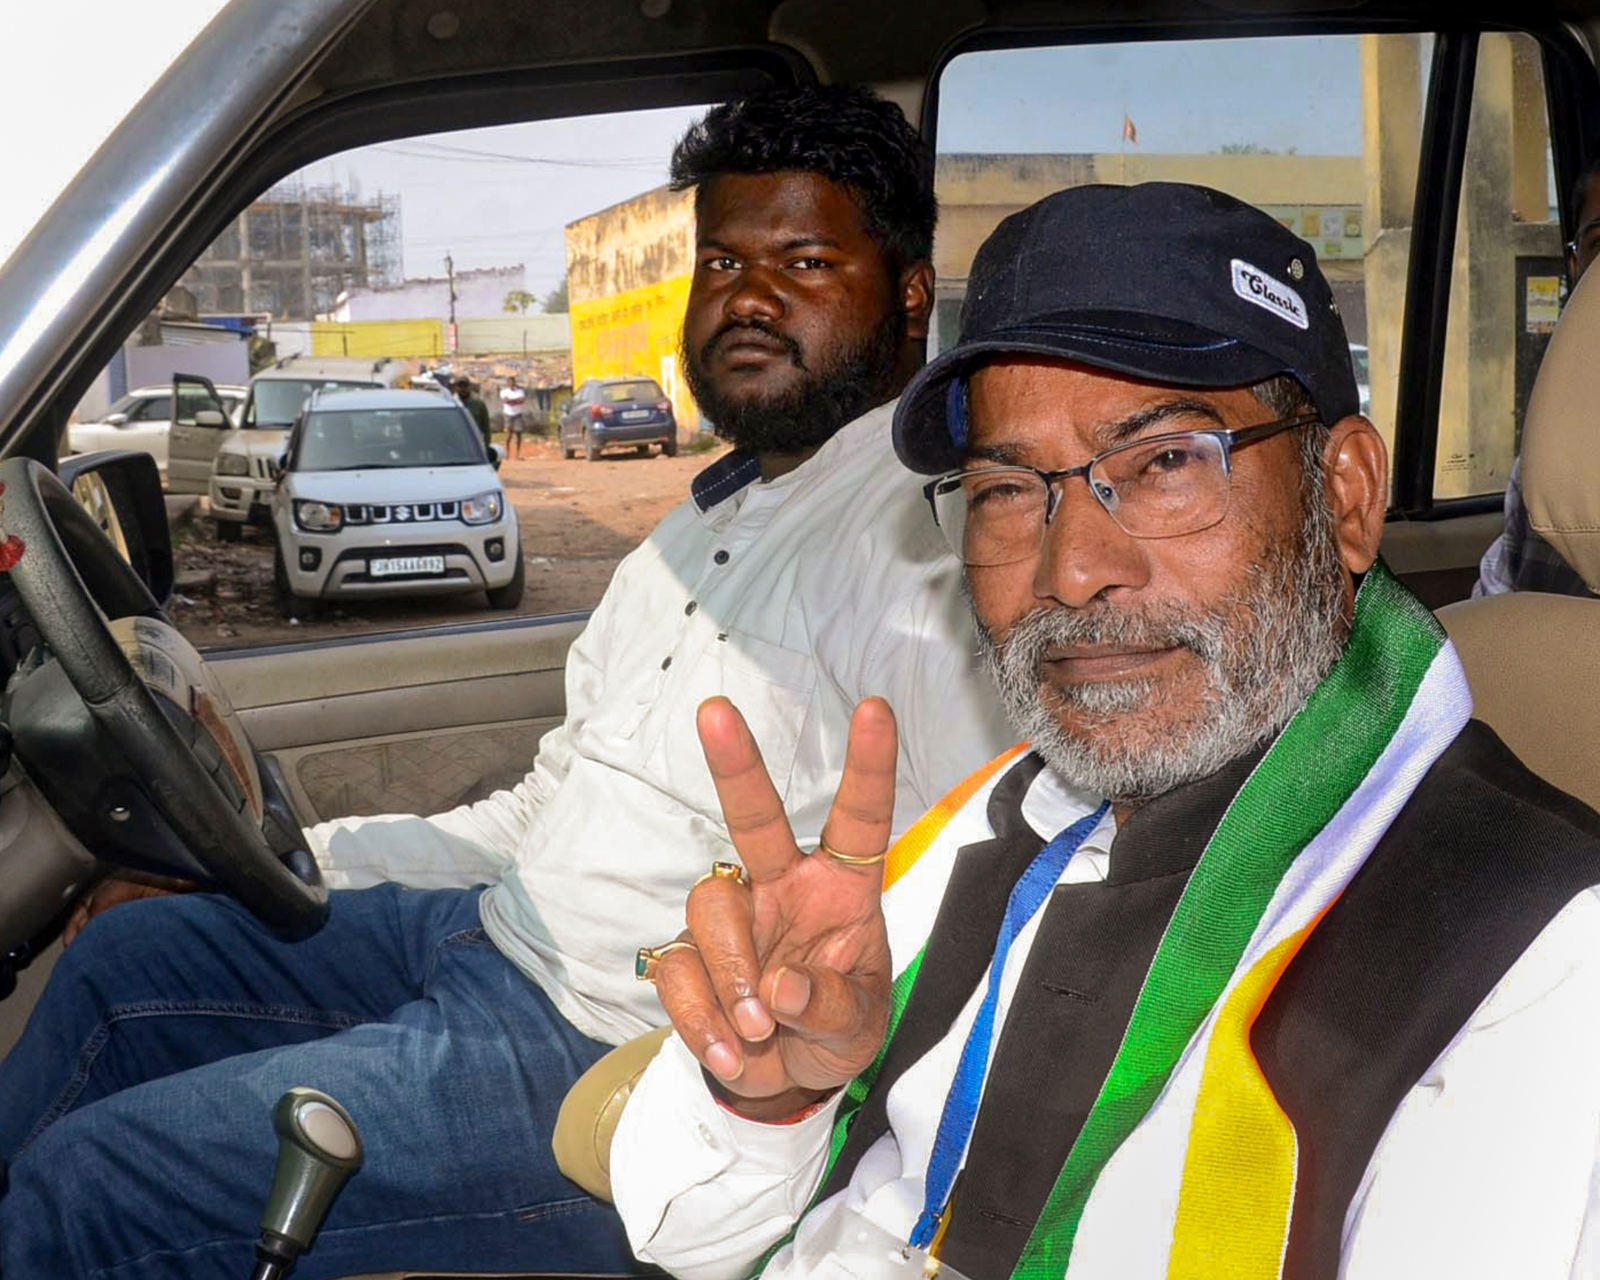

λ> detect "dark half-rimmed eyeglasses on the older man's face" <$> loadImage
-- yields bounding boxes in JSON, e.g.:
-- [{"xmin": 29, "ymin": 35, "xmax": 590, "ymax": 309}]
[{"xmin": 926, "ymin": 414, "xmax": 1322, "ymax": 568}]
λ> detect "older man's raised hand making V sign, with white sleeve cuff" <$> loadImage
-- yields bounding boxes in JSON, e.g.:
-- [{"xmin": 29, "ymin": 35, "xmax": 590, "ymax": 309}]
[{"xmin": 611, "ymin": 698, "xmax": 894, "ymax": 1280}]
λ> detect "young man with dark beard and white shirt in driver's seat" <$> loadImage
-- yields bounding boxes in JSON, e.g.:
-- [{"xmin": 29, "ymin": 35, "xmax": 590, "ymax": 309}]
[{"xmin": 0, "ymin": 90, "xmax": 1008, "ymax": 1280}]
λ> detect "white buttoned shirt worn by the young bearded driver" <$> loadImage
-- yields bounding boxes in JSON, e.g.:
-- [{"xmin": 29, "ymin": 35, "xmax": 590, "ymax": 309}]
[{"xmin": 310, "ymin": 405, "xmax": 1014, "ymax": 1043}]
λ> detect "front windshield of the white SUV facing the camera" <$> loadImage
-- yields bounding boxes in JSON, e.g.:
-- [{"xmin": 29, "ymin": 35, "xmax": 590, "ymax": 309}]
[{"xmin": 294, "ymin": 406, "xmax": 483, "ymax": 470}]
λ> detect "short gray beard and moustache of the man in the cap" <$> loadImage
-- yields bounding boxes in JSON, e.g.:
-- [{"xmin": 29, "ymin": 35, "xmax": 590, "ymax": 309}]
[{"xmin": 978, "ymin": 493, "xmax": 1349, "ymax": 803}]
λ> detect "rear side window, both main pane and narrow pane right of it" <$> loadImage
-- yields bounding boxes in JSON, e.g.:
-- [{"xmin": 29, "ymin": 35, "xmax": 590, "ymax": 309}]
[{"xmin": 933, "ymin": 32, "xmax": 1576, "ymax": 501}]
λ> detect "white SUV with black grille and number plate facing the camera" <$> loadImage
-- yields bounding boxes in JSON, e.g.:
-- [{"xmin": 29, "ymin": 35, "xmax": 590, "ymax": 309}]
[{"xmin": 272, "ymin": 390, "xmax": 523, "ymax": 616}]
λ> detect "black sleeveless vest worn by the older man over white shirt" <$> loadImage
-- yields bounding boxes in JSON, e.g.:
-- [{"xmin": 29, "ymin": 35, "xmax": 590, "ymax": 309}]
[{"xmin": 822, "ymin": 722, "xmax": 1600, "ymax": 1280}]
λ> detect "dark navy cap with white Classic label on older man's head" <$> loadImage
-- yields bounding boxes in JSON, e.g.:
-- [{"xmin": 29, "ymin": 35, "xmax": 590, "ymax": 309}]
[{"xmin": 894, "ymin": 182, "xmax": 1360, "ymax": 475}]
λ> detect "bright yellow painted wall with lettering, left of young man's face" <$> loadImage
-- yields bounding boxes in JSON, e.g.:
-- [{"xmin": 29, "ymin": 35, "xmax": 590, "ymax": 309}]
[{"xmin": 571, "ymin": 274, "xmax": 699, "ymax": 435}]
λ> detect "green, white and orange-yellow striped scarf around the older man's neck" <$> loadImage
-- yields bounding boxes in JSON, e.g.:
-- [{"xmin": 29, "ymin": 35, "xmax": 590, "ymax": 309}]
[{"xmin": 763, "ymin": 563, "xmax": 1472, "ymax": 1280}]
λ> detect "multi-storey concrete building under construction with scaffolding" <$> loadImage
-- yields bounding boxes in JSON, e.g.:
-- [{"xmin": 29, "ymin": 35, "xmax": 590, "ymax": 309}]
[{"xmin": 184, "ymin": 179, "xmax": 400, "ymax": 320}]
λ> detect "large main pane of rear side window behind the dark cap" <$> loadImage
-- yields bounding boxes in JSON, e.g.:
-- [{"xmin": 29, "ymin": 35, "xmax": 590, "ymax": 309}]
[{"xmin": 933, "ymin": 35, "xmax": 1430, "ymax": 470}]
